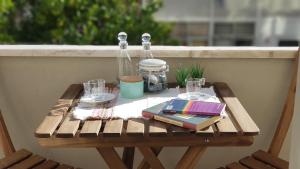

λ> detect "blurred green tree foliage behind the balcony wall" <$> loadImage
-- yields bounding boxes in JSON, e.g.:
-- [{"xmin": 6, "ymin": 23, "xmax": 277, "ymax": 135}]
[{"xmin": 0, "ymin": 0, "xmax": 176, "ymax": 45}]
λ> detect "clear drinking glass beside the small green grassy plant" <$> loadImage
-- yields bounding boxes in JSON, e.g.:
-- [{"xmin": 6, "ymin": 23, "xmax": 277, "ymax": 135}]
[{"xmin": 186, "ymin": 78, "xmax": 205, "ymax": 100}]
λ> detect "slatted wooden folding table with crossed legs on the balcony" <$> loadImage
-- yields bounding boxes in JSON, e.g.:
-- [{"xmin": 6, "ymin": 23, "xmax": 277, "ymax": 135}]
[{"xmin": 35, "ymin": 82, "xmax": 259, "ymax": 169}]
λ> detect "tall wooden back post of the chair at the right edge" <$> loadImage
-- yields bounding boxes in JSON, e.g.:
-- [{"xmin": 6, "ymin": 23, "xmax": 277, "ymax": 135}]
[{"xmin": 268, "ymin": 47, "xmax": 300, "ymax": 157}]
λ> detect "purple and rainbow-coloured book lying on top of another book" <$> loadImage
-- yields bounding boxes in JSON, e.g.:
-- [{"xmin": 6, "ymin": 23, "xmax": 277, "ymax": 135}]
[{"xmin": 163, "ymin": 99, "xmax": 226, "ymax": 116}]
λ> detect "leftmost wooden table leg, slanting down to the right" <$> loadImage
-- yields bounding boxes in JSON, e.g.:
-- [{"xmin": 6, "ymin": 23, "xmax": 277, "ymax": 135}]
[{"xmin": 97, "ymin": 147, "xmax": 126, "ymax": 169}]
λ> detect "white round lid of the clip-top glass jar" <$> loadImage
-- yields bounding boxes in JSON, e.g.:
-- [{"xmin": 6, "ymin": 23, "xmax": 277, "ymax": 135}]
[{"xmin": 139, "ymin": 59, "xmax": 167, "ymax": 71}]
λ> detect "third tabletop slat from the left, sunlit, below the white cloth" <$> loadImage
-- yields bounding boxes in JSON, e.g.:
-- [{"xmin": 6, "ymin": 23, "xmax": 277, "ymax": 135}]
[{"xmin": 80, "ymin": 120, "xmax": 102, "ymax": 137}]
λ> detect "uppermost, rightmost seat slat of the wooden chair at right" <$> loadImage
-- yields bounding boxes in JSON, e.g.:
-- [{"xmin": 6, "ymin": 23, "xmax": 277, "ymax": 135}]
[{"xmin": 252, "ymin": 150, "xmax": 289, "ymax": 169}]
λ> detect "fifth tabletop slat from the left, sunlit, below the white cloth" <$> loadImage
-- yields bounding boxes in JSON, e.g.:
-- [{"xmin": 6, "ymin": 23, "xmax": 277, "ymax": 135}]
[{"xmin": 126, "ymin": 119, "xmax": 145, "ymax": 136}]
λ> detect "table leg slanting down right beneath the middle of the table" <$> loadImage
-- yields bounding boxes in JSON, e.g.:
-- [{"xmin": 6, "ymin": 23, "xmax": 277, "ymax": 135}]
[{"xmin": 138, "ymin": 146, "xmax": 164, "ymax": 169}]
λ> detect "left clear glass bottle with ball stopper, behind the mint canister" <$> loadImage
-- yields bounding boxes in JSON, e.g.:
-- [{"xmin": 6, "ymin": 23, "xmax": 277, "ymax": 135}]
[{"xmin": 118, "ymin": 32, "xmax": 134, "ymax": 82}]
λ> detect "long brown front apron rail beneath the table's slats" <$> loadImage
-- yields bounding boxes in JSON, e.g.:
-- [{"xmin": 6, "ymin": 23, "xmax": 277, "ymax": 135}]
[{"xmin": 38, "ymin": 135, "xmax": 254, "ymax": 148}]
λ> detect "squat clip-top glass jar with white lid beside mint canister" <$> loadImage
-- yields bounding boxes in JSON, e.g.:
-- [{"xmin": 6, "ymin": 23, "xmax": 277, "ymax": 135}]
[{"xmin": 138, "ymin": 59, "xmax": 169, "ymax": 92}]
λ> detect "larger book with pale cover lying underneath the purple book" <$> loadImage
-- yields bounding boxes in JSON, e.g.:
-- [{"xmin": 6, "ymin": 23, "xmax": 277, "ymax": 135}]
[{"xmin": 142, "ymin": 101, "xmax": 222, "ymax": 130}]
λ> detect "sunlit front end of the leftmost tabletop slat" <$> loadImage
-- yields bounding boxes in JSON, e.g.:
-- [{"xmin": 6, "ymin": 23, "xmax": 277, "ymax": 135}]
[{"xmin": 35, "ymin": 115, "xmax": 63, "ymax": 137}]
